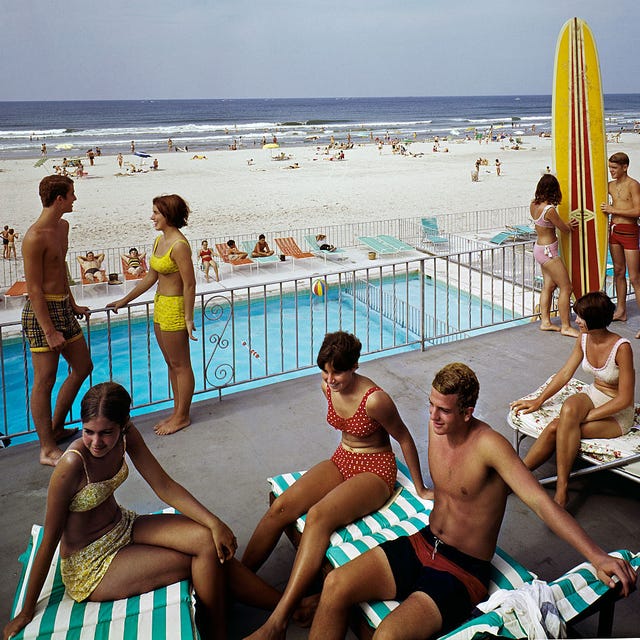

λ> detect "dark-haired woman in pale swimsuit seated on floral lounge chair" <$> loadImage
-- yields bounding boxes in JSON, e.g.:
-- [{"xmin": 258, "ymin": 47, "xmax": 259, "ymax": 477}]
[{"xmin": 511, "ymin": 291, "xmax": 636, "ymax": 507}]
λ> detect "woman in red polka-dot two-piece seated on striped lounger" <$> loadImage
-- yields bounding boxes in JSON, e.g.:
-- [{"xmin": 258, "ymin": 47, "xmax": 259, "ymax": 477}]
[{"xmin": 242, "ymin": 331, "xmax": 433, "ymax": 637}]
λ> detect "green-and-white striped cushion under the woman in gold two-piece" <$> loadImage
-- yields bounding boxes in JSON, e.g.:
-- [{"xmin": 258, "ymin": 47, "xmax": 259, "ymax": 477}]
[{"xmin": 11, "ymin": 510, "xmax": 199, "ymax": 640}]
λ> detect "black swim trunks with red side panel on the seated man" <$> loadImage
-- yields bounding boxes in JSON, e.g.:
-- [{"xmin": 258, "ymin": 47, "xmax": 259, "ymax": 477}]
[{"xmin": 380, "ymin": 527, "xmax": 491, "ymax": 633}]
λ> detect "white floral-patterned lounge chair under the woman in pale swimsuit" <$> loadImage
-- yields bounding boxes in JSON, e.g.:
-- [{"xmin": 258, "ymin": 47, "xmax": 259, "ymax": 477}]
[{"xmin": 507, "ymin": 376, "xmax": 640, "ymax": 484}]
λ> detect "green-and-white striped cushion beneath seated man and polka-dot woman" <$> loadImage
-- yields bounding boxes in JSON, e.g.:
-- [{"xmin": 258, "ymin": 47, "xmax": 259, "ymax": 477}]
[{"xmin": 268, "ymin": 461, "xmax": 640, "ymax": 640}]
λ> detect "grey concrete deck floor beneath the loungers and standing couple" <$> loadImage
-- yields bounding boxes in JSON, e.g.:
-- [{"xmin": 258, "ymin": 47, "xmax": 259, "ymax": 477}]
[{"xmin": 0, "ymin": 318, "xmax": 640, "ymax": 639}]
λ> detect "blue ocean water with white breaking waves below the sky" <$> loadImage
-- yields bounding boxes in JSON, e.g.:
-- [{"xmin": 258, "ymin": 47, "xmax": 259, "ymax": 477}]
[{"xmin": 0, "ymin": 94, "xmax": 640, "ymax": 159}]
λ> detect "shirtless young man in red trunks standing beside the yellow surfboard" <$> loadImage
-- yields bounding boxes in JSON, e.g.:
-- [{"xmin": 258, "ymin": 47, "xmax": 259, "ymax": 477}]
[{"xmin": 600, "ymin": 152, "xmax": 640, "ymax": 338}]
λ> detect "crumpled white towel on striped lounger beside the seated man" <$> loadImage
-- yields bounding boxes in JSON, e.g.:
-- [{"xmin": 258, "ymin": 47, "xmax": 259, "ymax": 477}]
[{"xmin": 477, "ymin": 580, "xmax": 567, "ymax": 638}]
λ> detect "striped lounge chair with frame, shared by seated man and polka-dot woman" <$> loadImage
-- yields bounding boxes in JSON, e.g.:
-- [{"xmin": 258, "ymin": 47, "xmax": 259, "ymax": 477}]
[{"xmin": 268, "ymin": 461, "xmax": 640, "ymax": 640}]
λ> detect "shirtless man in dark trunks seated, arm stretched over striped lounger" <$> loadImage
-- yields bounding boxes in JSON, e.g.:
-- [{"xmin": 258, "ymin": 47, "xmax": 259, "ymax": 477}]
[{"xmin": 309, "ymin": 362, "xmax": 636, "ymax": 640}]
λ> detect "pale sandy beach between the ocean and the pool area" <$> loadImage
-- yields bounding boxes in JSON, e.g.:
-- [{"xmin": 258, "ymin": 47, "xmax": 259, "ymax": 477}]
[{"xmin": 0, "ymin": 133, "xmax": 640, "ymax": 251}]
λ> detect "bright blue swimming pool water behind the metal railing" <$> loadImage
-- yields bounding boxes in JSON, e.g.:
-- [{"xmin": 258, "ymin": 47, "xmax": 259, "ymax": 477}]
[{"xmin": 0, "ymin": 272, "xmax": 512, "ymax": 438}]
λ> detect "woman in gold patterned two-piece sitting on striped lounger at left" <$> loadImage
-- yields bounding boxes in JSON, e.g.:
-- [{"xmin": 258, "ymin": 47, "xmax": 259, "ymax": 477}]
[{"xmin": 4, "ymin": 382, "xmax": 280, "ymax": 638}]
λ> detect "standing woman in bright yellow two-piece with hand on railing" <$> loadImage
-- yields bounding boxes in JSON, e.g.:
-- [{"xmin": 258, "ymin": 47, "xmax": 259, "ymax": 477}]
[{"xmin": 107, "ymin": 194, "xmax": 197, "ymax": 435}]
